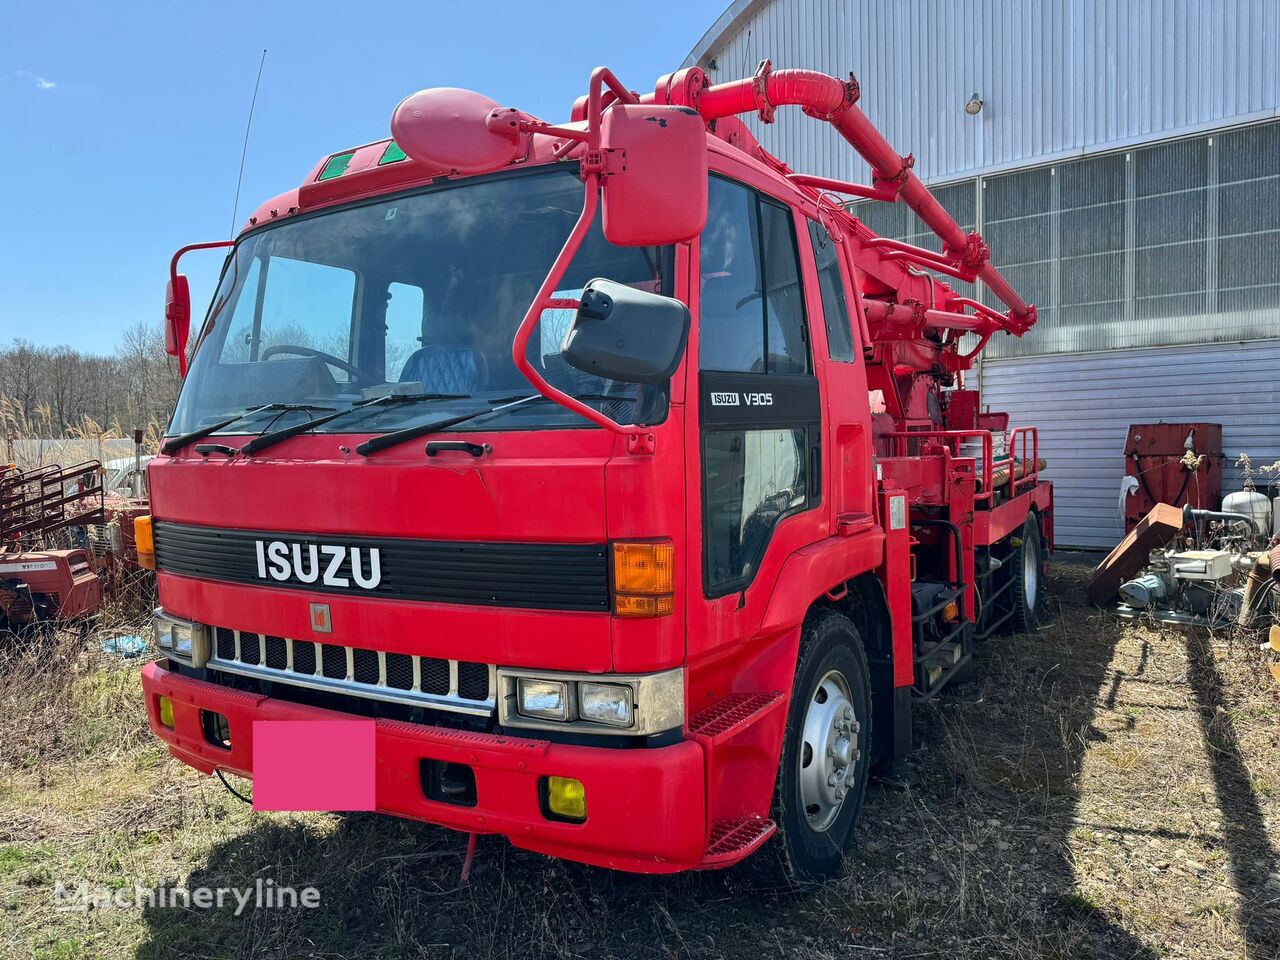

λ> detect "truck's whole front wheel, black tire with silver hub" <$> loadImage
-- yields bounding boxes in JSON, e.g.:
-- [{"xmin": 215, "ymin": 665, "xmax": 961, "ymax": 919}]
[{"xmin": 762, "ymin": 609, "xmax": 872, "ymax": 887}]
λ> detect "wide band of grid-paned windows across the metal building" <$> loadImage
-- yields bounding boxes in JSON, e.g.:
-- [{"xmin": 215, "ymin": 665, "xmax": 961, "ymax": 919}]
[{"xmin": 854, "ymin": 122, "xmax": 1280, "ymax": 358}]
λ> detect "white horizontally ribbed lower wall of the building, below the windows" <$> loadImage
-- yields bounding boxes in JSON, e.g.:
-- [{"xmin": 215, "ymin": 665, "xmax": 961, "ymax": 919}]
[{"xmin": 982, "ymin": 340, "xmax": 1280, "ymax": 549}]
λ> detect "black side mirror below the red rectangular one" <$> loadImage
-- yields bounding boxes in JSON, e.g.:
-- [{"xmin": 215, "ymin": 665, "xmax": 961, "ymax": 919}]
[{"xmin": 561, "ymin": 279, "xmax": 690, "ymax": 384}]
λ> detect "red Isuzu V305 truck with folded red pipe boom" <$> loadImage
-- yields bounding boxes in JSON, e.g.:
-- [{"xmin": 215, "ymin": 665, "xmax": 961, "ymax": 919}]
[{"xmin": 138, "ymin": 61, "xmax": 1052, "ymax": 881}]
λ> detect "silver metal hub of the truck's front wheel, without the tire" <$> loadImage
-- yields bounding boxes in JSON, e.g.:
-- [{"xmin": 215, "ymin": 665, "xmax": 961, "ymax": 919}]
[{"xmin": 799, "ymin": 669, "xmax": 861, "ymax": 833}]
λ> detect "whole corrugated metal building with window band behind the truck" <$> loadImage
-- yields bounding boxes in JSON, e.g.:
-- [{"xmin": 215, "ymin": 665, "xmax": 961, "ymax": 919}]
[{"xmin": 686, "ymin": 0, "xmax": 1280, "ymax": 547}]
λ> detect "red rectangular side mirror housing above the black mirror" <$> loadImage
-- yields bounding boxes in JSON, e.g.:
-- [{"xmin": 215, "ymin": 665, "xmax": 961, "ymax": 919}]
[{"xmin": 600, "ymin": 104, "xmax": 707, "ymax": 247}]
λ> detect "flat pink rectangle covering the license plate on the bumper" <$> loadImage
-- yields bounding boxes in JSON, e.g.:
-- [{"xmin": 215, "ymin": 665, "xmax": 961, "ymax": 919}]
[{"xmin": 253, "ymin": 719, "xmax": 378, "ymax": 810}]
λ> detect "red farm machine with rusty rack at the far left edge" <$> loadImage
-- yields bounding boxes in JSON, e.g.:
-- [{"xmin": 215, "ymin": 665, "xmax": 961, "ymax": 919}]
[{"xmin": 0, "ymin": 461, "xmax": 102, "ymax": 634}]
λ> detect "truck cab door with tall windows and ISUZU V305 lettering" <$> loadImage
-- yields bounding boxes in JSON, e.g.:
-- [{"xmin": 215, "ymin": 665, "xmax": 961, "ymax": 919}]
[{"xmin": 687, "ymin": 177, "xmax": 826, "ymax": 655}]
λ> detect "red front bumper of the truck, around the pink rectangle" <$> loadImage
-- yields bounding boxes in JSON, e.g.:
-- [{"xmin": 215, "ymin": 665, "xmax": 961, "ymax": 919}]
[{"xmin": 142, "ymin": 663, "xmax": 708, "ymax": 873}]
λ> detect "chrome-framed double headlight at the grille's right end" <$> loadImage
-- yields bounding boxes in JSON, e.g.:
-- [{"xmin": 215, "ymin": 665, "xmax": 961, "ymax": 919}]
[{"xmin": 498, "ymin": 667, "xmax": 685, "ymax": 736}]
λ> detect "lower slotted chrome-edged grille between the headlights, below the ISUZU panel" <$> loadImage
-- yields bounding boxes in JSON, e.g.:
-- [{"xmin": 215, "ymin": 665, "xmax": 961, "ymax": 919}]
[{"xmin": 209, "ymin": 627, "xmax": 495, "ymax": 716}]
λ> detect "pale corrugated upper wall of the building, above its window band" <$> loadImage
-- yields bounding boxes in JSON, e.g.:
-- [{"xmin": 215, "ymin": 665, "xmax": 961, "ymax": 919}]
[{"xmin": 686, "ymin": 0, "xmax": 1280, "ymax": 182}]
